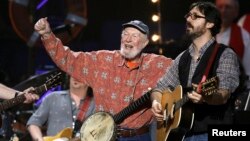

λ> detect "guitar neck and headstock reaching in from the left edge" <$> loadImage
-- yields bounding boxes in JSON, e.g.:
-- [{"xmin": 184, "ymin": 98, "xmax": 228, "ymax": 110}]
[{"xmin": 0, "ymin": 72, "xmax": 62, "ymax": 127}]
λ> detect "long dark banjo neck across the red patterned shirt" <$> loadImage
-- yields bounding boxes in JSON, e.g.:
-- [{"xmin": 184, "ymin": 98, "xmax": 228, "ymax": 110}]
[{"xmin": 113, "ymin": 90, "xmax": 151, "ymax": 124}]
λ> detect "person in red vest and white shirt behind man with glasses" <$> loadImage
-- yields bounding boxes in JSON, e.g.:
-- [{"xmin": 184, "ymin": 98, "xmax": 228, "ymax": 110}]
[{"xmin": 215, "ymin": 0, "xmax": 250, "ymax": 89}]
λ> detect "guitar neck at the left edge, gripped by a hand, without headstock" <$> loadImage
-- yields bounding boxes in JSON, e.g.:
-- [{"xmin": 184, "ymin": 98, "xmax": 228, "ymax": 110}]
[{"xmin": 0, "ymin": 84, "xmax": 47, "ymax": 111}]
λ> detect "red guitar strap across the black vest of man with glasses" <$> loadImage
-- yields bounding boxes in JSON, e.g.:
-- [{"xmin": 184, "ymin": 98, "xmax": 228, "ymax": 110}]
[{"xmin": 197, "ymin": 43, "xmax": 219, "ymax": 93}]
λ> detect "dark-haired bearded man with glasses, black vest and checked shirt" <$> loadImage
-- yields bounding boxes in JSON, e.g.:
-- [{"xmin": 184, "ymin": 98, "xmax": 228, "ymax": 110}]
[{"xmin": 151, "ymin": 2, "xmax": 239, "ymax": 141}]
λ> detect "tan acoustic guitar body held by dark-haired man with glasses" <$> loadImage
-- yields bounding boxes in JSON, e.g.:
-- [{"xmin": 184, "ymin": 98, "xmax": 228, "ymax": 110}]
[{"xmin": 157, "ymin": 85, "xmax": 194, "ymax": 141}]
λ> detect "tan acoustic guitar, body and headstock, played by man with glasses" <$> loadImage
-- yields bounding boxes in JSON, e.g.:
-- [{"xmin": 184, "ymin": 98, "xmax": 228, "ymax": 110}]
[{"xmin": 157, "ymin": 77, "xmax": 218, "ymax": 141}]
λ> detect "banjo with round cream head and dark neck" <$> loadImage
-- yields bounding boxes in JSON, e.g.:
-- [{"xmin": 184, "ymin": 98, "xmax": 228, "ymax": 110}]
[{"xmin": 80, "ymin": 90, "xmax": 152, "ymax": 141}]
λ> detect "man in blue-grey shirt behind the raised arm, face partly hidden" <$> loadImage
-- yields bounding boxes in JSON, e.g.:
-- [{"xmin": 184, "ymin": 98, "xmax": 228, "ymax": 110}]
[{"xmin": 27, "ymin": 77, "xmax": 95, "ymax": 141}]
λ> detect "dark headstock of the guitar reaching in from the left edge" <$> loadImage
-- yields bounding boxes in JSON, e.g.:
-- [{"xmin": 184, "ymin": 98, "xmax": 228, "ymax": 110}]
[{"xmin": 45, "ymin": 72, "xmax": 63, "ymax": 89}]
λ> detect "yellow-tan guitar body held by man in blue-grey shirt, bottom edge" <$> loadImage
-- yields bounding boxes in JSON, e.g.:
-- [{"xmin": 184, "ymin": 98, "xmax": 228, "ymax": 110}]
[{"xmin": 43, "ymin": 127, "xmax": 73, "ymax": 141}]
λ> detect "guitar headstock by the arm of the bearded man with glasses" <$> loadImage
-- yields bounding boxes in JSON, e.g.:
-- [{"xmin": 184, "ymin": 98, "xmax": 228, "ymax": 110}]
[{"xmin": 194, "ymin": 76, "xmax": 219, "ymax": 96}]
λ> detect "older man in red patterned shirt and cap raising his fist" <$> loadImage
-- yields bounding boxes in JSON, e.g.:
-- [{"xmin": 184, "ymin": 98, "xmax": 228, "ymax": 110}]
[{"xmin": 34, "ymin": 18, "xmax": 172, "ymax": 141}]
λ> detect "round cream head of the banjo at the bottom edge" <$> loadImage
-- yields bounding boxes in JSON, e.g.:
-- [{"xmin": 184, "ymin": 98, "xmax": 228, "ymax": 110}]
[{"xmin": 80, "ymin": 112, "xmax": 116, "ymax": 141}]
